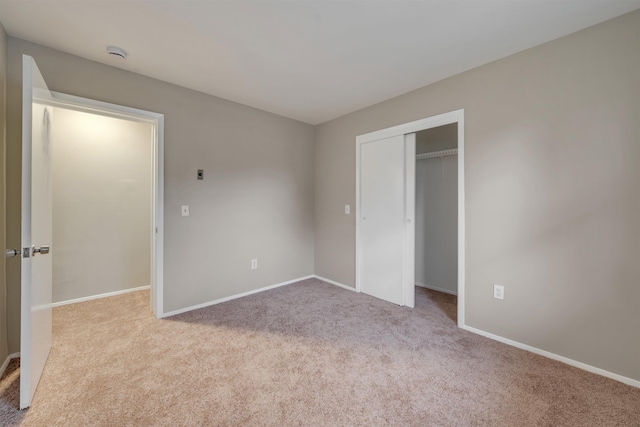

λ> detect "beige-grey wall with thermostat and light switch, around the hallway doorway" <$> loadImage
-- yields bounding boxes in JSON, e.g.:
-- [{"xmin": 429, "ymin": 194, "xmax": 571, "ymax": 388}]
[{"xmin": 7, "ymin": 37, "xmax": 314, "ymax": 351}]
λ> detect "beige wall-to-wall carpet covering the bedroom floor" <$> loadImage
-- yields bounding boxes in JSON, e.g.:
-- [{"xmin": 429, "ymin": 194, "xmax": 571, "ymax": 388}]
[{"xmin": 0, "ymin": 279, "xmax": 640, "ymax": 427}]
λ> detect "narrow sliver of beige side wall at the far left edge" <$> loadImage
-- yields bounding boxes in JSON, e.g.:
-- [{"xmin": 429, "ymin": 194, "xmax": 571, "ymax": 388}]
[{"xmin": 0, "ymin": 24, "xmax": 9, "ymax": 364}]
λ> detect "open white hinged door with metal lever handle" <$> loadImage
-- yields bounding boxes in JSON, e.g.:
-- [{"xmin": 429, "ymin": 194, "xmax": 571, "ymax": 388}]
[{"xmin": 20, "ymin": 55, "xmax": 52, "ymax": 409}]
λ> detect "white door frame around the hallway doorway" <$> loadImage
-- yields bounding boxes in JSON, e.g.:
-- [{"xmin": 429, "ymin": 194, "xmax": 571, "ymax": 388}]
[{"xmin": 51, "ymin": 92, "xmax": 164, "ymax": 318}]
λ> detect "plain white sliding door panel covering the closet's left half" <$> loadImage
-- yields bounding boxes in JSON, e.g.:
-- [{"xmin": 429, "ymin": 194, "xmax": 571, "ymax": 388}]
[{"xmin": 358, "ymin": 134, "xmax": 415, "ymax": 307}]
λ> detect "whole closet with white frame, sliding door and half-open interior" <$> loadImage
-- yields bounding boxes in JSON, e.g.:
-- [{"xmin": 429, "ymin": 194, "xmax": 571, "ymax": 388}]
[{"xmin": 355, "ymin": 110, "xmax": 465, "ymax": 327}]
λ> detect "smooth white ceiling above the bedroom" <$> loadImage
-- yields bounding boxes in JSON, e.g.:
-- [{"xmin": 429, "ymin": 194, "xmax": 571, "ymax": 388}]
[{"xmin": 0, "ymin": 0, "xmax": 640, "ymax": 124}]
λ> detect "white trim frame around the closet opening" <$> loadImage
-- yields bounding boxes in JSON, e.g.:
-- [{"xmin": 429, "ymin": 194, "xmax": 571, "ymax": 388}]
[{"xmin": 355, "ymin": 109, "xmax": 466, "ymax": 327}]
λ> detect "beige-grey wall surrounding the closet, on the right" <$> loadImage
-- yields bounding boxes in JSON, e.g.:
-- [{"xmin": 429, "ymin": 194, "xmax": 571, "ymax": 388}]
[{"xmin": 315, "ymin": 12, "xmax": 640, "ymax": 380}]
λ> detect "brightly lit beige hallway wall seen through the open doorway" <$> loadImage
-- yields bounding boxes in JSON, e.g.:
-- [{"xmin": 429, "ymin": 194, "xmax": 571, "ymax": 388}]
[{"xmin": 52, "ymin": 108, "xmax": 153, "ymax": 302}]
